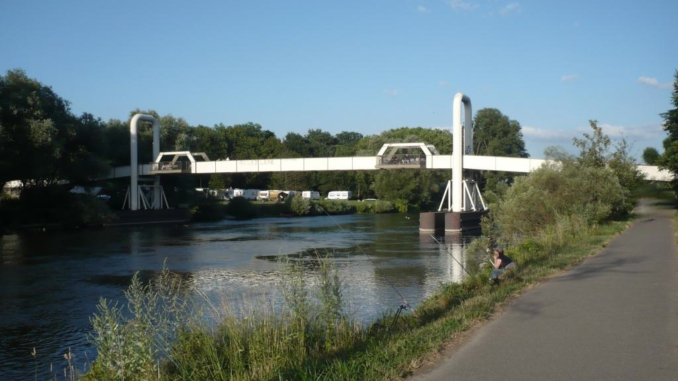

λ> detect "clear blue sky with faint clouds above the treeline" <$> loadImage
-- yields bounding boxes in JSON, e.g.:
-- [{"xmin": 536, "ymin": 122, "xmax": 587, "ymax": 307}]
[{"xmin": 0, "ymin": 0, "xmax": 678, "ymax": 157}]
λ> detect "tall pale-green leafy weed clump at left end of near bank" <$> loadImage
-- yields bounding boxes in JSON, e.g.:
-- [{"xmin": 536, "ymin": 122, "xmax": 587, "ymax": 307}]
[{"xmin": 84, "ymin": 268, "xmax": 190, "ymax": 381}]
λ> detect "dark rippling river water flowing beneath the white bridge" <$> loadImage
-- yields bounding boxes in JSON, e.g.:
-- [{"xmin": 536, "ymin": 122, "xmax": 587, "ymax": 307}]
[{"xmin": 0, "ymin": 214, "xmax": 478, "ymax": 380}]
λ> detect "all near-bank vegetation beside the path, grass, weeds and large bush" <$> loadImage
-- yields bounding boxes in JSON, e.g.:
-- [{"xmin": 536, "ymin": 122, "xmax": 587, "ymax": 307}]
[{"xmin": 46, "ymin": 122, "xmax": 652, "ymax": 380}]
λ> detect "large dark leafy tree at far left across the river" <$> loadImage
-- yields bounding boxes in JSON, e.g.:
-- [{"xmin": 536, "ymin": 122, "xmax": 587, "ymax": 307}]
[{"xmin": 0, "ymin": 70, "xmax": 107, "ymax": 186}]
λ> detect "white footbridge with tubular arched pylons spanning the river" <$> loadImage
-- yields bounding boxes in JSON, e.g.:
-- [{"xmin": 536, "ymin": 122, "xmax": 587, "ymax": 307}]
[{"xmin": 121, "ymin": 93, "xmax": 673, "ymax": 213}]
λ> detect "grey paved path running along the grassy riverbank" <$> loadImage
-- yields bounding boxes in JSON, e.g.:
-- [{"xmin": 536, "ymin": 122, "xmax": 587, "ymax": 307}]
[{"xmin": 412, "ymin": 200, "xmax": 678, "ymax": 381}]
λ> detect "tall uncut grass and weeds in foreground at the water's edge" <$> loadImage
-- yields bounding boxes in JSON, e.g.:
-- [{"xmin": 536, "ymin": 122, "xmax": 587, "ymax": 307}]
[{"xmin": 85, "ymin": 252, "xmax": 367, "ymax": 380}]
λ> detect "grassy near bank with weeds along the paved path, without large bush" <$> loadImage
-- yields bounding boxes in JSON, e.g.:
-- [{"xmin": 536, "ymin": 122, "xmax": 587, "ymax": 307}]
[{"xmin": 85, "ymin": 211, "xmax": 628, "ymax": 380}]
